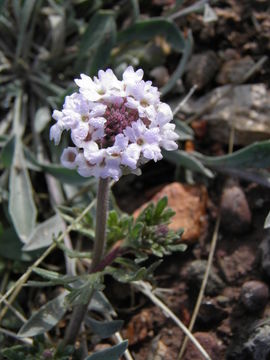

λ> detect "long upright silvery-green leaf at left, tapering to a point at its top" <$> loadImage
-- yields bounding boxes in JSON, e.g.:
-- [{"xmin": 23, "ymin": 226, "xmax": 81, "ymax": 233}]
[{"xmin": 9, "ymin": 138, "xmax": 37, "ymax": 243}]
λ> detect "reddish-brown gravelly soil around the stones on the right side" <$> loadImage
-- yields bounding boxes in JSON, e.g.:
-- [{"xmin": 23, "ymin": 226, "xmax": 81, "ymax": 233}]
[{"xmin": 109, "ymin": 0, "xmax": 270, "ymax": 360}]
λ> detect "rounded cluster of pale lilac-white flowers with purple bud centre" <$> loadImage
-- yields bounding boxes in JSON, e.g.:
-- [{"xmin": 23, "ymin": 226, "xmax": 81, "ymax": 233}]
[{"xmin": 50, "ymin": 66, "xmax": 178, "ymax": 180}]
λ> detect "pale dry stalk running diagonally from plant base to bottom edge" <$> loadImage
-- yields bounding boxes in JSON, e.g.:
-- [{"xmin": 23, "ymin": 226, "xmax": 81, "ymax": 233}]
[{"xmin": 132, "ymin": 281, "xmax": 211, "ymax": 360}]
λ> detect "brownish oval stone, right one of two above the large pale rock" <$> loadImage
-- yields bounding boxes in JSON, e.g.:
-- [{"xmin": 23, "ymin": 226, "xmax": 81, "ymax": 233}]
[{"xmin": 216, "ymin": 56, "xmax": 255, "ymax": 85}]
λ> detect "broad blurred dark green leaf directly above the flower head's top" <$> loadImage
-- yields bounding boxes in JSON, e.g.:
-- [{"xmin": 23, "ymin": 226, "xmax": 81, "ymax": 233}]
[{"xmin": 75, "ymin": 10, "xmax": 116, "ymax": 75}]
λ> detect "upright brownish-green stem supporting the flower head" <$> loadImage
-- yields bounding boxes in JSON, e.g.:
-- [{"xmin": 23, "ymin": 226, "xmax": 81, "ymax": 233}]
[{"xmin": 61, "ymin": 178, "xmax": 110, "ymax": 347}]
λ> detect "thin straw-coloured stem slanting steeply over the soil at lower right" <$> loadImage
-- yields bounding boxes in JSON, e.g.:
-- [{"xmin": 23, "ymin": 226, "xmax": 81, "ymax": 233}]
[{"xmin": 178, "ymin": 215, "xmax": 220, "ymax": 360}]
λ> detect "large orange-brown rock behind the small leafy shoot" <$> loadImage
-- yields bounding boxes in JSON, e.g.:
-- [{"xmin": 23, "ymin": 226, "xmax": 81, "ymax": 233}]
[{"xmin": 134, "ymin": 182, "xmax": 207, "ymax": 243}]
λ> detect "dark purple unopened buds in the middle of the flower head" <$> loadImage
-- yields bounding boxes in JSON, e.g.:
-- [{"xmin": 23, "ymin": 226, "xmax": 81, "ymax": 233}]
[{"xmin": 102, "ymin": 103, "xmax": 139, "ymax": 147}]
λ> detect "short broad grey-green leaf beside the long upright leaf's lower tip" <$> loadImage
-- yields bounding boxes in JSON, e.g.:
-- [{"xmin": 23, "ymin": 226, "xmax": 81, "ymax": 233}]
[{"xmin": 23, "ymin": 214, "xmax": 65, "ymax": 251}]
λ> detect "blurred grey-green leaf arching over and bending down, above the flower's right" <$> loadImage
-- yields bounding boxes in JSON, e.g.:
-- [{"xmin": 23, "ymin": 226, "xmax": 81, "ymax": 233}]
[{"xmin": 117, "ymin": 17, "xmax": 185, "ymax": 52}]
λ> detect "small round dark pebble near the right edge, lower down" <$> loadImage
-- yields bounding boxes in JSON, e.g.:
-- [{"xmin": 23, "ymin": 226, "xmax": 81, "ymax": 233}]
[{"xmin": 241, "ymin": 280, "xmax": 269, "ymax": 312}]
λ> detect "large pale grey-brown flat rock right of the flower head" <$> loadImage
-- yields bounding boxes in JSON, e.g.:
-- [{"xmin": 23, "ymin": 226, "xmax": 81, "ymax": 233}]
[{"xmin": 185, "ymin": 84, "xmax": 270, "ymax": 145}]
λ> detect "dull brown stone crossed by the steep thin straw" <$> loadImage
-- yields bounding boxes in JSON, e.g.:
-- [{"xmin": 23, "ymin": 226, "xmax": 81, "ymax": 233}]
[{"xmin": 186, "ymin": 260, "xmax": 225, "ymax": 295}]
